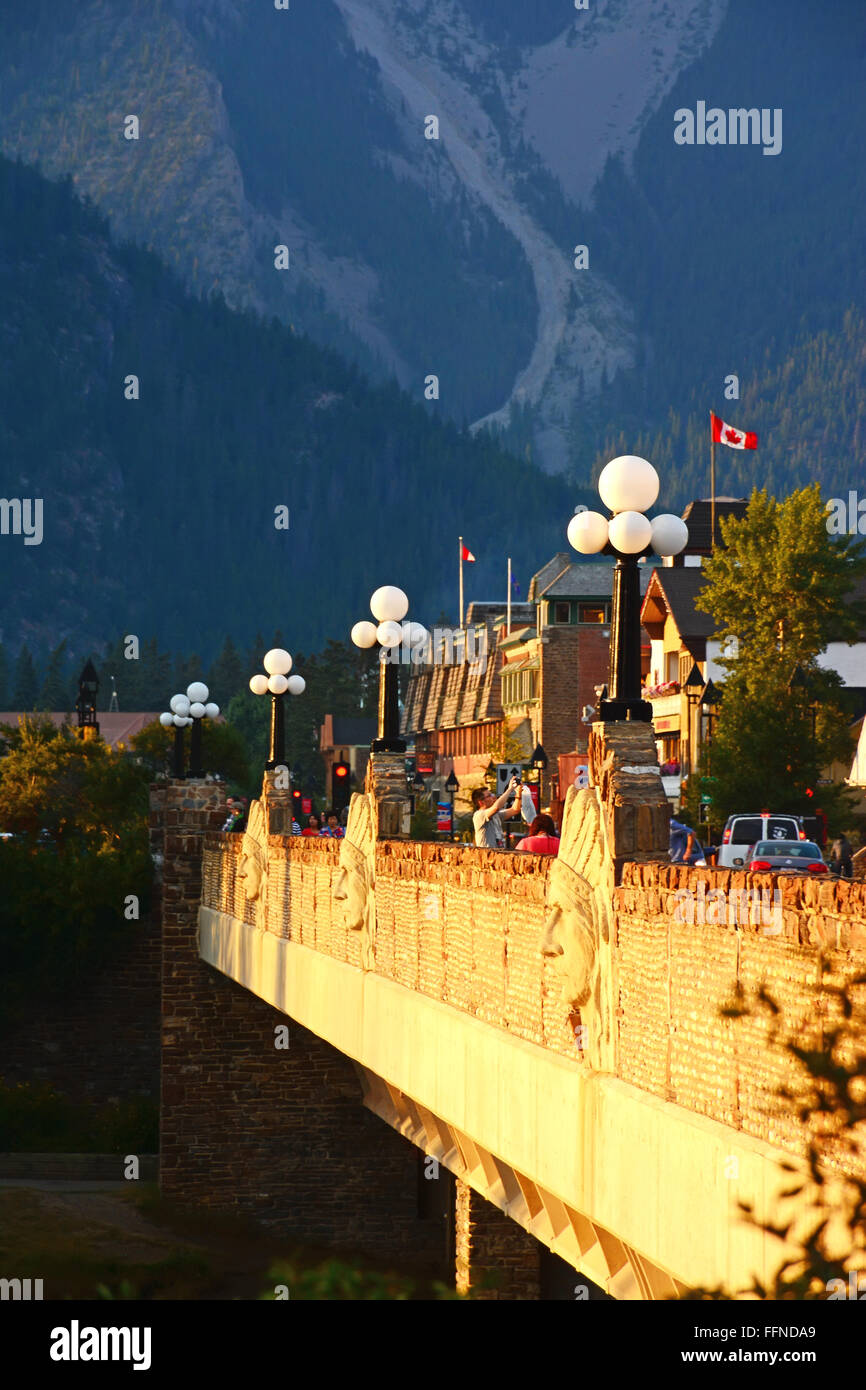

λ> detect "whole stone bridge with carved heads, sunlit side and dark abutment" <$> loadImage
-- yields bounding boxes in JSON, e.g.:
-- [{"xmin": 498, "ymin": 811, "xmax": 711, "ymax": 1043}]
[{"xmin": 152, "ymin": 726, "xmax": 866, "ymax": 1298}]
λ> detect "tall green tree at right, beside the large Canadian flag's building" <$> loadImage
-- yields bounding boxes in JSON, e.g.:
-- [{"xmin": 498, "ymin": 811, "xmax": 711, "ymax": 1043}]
[{"xmin": 699, "ymin": 485, "xmax": 866, "ymax": 831}]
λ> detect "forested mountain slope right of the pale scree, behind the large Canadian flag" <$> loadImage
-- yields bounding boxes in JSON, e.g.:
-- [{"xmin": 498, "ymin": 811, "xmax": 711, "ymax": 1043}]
[{"xmin": 561, "ymin": 0, "xmax": 866, "ymax": 502}]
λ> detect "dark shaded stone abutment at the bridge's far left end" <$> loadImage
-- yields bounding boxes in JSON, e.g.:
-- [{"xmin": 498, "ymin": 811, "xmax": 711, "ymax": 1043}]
[{"xmin": 157, "ymin": 781, "xmax": 448, "ymax": 1279}]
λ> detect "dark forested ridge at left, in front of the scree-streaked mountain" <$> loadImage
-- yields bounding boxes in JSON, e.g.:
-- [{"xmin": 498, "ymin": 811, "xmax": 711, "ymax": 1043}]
[{"xmin": 0, "ymin": 160, "xmax": 575, "ymax": 661}]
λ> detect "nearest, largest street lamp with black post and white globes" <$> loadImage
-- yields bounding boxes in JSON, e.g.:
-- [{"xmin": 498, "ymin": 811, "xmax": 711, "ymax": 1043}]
[{"xmin": 567, "ymin": 453, "xmax": 688, "ymax": 723}]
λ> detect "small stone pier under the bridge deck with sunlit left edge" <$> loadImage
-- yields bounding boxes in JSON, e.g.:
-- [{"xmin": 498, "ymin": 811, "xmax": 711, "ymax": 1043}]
[{"xmin": 455, "ymin": 1179, "xmax": 542, "ymax": 1301}]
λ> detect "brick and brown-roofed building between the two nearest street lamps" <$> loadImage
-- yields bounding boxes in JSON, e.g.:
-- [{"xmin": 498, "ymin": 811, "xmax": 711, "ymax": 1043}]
[{"xmin": 402, "ymin": 552, "xmax": 652, "ymax": 810}]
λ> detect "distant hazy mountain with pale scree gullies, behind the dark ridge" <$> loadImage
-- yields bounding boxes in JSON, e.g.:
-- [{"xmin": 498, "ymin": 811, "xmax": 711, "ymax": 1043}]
[{"xmin": 0, "ymin": 0, "xmax": 866, "ymax": 505}]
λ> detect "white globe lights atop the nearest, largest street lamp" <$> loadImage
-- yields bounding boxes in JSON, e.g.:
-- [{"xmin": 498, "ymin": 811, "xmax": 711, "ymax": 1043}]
[{"xmin": 567, "ymin": 453, "xmax": 688, "ymax": 557}]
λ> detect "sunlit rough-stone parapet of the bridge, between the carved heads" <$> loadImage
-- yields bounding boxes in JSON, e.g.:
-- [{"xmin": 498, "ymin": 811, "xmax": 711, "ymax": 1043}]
[{"xmin": 203, "ymin": 834, "xmax": 866, "ymax": 1152}]
